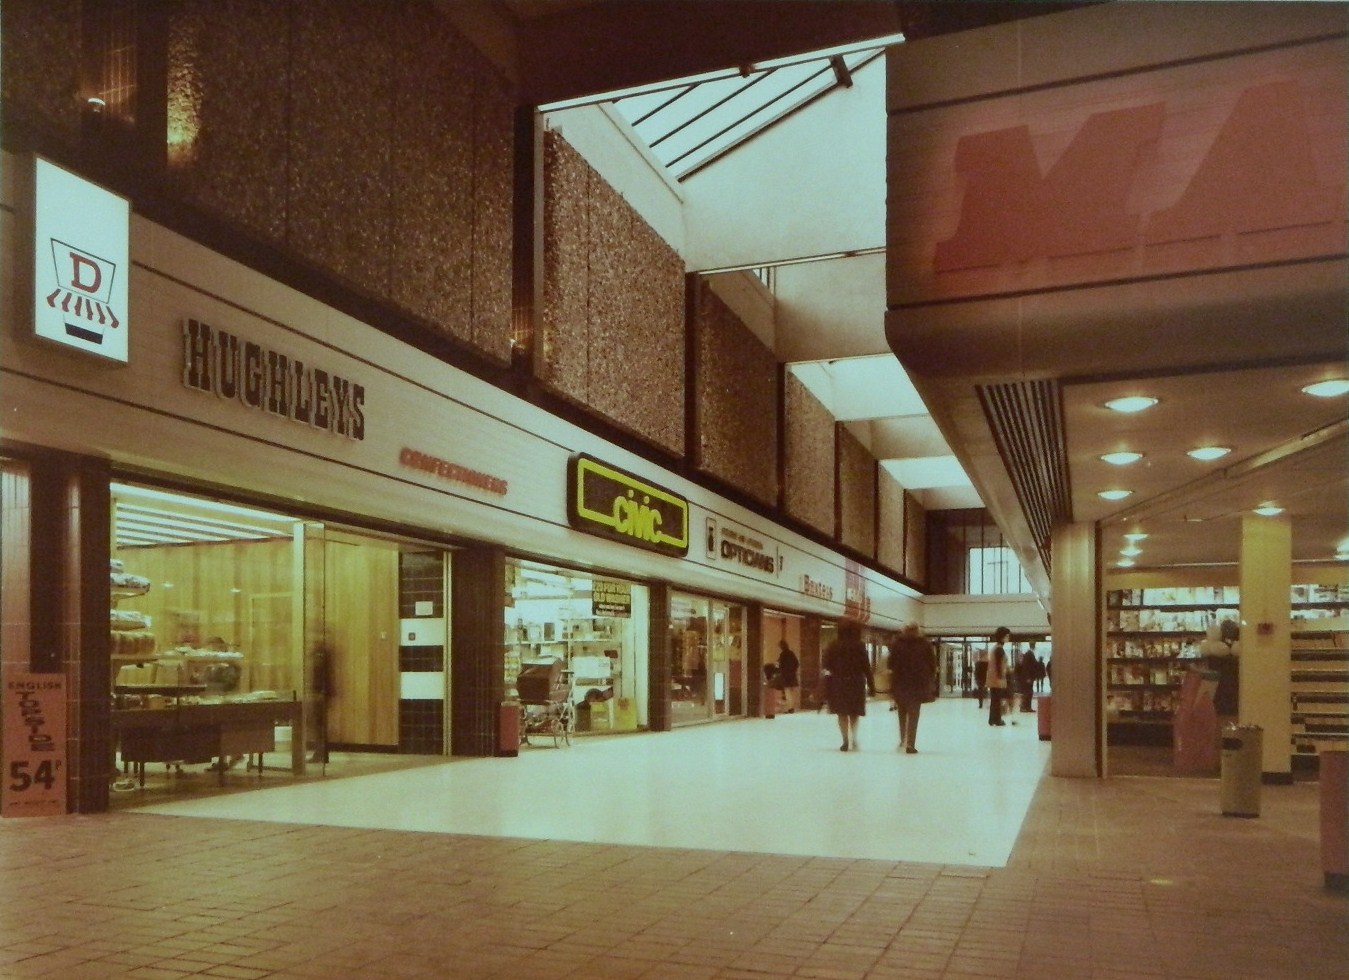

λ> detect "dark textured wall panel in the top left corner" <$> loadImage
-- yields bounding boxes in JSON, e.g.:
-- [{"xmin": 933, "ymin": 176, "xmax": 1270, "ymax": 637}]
[{"xmin": 0, "ymin": 0, "xmax": 82, "ymax": 139}]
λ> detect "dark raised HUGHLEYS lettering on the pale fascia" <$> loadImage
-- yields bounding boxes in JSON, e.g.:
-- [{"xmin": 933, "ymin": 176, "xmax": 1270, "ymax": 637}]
[{"xmin": 182, "ymin": 320, "xmax": 366, "ymax": 441}]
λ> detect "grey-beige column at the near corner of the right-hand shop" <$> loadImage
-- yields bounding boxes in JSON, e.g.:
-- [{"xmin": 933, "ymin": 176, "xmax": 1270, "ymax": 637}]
[{"xmin": 1050, "ymin": 524, "xmax": 1105, "ymax": 778}]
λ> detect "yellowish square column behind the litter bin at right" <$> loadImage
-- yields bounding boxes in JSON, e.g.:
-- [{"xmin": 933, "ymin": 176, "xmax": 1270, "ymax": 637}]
[{"xmin": 1237, "ymin": 514, "xmax": 1292, "ymax": 783}]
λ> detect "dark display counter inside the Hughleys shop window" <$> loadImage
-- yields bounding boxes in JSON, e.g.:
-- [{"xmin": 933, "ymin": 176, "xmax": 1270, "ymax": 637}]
[{"xmin": 112, "ymin": 687, "xmax": 305, "ymax": 787}]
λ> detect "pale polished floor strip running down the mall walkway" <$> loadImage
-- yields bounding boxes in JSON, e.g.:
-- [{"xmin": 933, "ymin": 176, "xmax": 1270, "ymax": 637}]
[{"xmin": 134, "ymin": 699, "xmax": 1050, "ymax": 867}]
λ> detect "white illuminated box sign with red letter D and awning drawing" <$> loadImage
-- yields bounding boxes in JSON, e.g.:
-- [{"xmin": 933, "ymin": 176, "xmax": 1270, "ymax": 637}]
[{"xmin": 32, "ymin": 158, "xmax": 131, "ymax": 363}]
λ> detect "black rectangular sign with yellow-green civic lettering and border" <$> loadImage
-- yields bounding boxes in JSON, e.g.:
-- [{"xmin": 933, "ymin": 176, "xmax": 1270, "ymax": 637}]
[{"xmin": 567, "ymin": 452, "xmax": 688, "ymax": 557}]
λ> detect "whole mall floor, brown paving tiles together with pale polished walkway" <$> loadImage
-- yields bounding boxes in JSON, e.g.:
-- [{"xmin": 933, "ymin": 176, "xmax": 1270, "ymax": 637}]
[{"xmin": 0, "ymin": 702, "xmax": 1349, "ymax": 980}]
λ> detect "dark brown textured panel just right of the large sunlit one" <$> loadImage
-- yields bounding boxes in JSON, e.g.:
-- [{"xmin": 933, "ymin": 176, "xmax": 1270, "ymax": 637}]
[{"xmin": 695, "ymin": 289, "xmax": 777, "ymax": 505}]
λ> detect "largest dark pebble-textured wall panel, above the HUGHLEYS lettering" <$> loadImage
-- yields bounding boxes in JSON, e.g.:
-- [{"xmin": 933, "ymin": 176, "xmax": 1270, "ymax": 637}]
[{"xmin": 171, "ymin": 0, "xmax": 514, "ymax": 363}]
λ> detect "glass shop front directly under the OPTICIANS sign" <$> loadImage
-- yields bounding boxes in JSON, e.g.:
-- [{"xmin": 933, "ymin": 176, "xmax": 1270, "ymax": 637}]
[{"xmin": 670, "ymin": 593, "xmax": 746, "ymax": 725}]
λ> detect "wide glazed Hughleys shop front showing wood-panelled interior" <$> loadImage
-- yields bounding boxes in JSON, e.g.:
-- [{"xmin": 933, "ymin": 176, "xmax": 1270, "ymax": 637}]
[{"xmin": 111, "ymin": 483, "xmax": 449, "ymax": 803}]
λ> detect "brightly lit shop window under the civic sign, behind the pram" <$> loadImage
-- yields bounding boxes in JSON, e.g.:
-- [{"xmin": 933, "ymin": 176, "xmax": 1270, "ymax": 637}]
[{"xmin": 506, "ymin": 559, "xmax": 650, "ymax": 744}]
